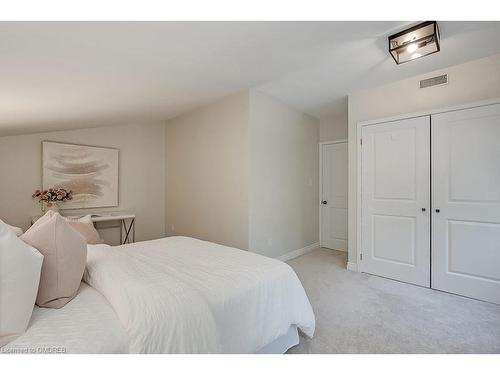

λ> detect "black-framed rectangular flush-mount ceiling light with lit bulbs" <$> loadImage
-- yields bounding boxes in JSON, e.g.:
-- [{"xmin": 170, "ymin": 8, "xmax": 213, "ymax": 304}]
[{"xmin": 389, "ymin": 21, "xmax": 440, "ymax": 64}]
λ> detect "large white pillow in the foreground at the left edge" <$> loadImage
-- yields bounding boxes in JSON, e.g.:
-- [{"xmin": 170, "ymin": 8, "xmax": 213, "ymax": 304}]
[{"xmin": 0, "ymin": 220, "xmax": 43, "ymax": 347}]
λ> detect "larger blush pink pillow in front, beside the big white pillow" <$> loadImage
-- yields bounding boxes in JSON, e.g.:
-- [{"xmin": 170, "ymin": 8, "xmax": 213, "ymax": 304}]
[{"xmin": 21, "ymin": 212, "xmax": 87, "ymax": 308}]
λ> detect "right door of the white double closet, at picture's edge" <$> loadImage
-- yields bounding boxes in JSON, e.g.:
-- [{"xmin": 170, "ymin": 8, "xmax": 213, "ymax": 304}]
[{"xmin": 432, "ymin": 105, "xmax": 500, "ymax": 303}]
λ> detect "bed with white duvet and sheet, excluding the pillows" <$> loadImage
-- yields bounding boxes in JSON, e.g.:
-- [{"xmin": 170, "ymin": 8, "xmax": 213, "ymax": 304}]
[{"xmin": 5, "ymin": 237, "xmax": 315, "ymax": 353}]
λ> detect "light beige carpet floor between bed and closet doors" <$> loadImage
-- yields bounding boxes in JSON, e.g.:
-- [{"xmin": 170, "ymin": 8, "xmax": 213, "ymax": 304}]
[{"xmin": 288, "ymin": 249, "xmax": 500, "ymax": 353}]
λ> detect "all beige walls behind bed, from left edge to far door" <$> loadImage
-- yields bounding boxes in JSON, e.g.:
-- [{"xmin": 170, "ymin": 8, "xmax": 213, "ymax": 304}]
[{"xmin": 0, "ymin": 91, "xmax": 319, "ymax": 257}]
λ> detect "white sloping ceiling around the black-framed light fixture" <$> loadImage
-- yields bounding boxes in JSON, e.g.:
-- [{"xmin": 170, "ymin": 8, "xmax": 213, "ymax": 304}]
[{"xmin": 0, "ymin": 22, "xmax": 500, "ymax": 135}]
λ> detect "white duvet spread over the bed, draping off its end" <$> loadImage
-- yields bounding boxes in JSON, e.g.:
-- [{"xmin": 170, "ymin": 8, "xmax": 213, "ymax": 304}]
[{"xmin": 84, "ymin": 237, "xmax": 315, "ymax": 353}]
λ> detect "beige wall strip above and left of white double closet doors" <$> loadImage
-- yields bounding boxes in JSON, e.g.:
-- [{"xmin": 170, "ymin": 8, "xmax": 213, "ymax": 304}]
[{"xmin": 348, "ymin": 55, "xmax": 500, "ymax": 262}]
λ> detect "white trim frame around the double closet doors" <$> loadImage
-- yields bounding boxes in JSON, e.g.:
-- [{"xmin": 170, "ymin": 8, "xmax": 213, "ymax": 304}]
[{"xmin": 356, "ymin": 97, "xmax": 500, "ymax": 272}]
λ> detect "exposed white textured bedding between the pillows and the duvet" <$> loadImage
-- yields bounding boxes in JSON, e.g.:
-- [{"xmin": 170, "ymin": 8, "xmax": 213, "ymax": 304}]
[{"xmin": 1, "ymin": 283, "xmax": 129, "ymax": 354}]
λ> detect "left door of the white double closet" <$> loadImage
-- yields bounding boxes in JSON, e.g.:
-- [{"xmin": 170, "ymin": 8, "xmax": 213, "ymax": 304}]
[{"xmin": 360, "ymin": 116, "xmax": 430, "ymax": 287}]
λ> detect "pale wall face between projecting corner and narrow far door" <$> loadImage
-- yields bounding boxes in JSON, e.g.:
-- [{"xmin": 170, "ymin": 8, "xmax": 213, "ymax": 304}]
[{"xmin": 248, "ymin": 91, "xmax": 319, "ymax": 257}]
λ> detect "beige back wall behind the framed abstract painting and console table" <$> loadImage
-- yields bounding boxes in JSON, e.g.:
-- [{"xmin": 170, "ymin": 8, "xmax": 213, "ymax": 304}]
[{"xmin": 0, "ymin": 123, "xmax": 165, "ymax": 244}]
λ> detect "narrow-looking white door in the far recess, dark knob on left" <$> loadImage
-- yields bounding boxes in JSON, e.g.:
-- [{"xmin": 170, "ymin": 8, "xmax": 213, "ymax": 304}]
[{"xmin": 321, "ymin": 142, "xmax": 348, "ymax": 251}]
